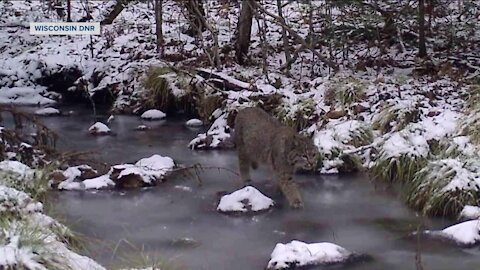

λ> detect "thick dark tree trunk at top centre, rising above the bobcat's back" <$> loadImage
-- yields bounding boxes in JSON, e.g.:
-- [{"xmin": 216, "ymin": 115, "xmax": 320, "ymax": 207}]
[{"xmin": 235, "ymin": 0, "xmax": 255, "ymax": 65}]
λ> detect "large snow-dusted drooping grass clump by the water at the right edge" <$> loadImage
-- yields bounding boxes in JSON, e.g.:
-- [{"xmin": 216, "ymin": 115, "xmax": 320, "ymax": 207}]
[{"xmin": 406, "ymin": 158, "xmax": 480, "ymax": 217}]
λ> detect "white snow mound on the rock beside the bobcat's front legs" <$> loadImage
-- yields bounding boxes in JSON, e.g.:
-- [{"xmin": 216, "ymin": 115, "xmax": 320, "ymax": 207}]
[{"xmin": 217, "ymin": 186, "xmax": 274, "ymax": 212}]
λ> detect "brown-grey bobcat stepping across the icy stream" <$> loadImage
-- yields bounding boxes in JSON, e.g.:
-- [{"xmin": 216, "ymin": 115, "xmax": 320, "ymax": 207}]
[{"xmin": 235, "ymin": 108, "xmax": 319, "ymax": 208}]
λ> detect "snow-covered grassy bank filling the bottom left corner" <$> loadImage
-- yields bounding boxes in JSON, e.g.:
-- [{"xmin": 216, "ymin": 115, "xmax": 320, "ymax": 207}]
[{"xmin": 0, "ymin": 161, "xmax": 105, "ymax": 270}]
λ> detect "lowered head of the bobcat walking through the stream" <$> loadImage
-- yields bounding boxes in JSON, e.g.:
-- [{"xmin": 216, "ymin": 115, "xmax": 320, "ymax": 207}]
[{"xmin": 287, "ymin": 134, "xmax": 320, "ymax": 171}]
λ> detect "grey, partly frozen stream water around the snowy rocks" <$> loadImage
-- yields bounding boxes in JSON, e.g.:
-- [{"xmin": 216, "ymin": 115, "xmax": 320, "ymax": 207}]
[{"xmin": 37, "ymin": 105, "xmax": 480, "ymax": 270}]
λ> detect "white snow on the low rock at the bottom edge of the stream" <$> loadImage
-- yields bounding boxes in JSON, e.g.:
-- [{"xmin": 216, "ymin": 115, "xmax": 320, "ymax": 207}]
[{"xmin": 267, "ymin": 240, "xmax": 353, "ymax": 269}]
